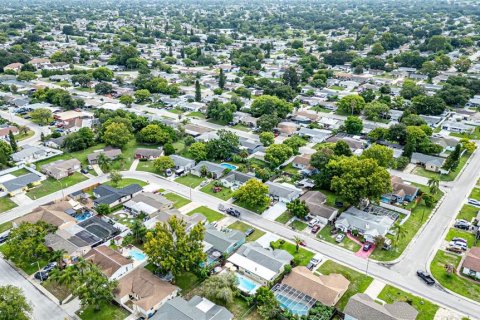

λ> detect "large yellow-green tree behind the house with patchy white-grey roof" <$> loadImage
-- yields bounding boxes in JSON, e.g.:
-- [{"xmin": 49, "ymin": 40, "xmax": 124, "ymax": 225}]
[{"xmin": 327, "ymin": 157, "xmax": 392, "ymax": 205}]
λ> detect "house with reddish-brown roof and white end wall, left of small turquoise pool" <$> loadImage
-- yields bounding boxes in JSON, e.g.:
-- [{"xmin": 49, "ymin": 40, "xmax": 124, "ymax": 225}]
[{"xmin": 84, "ymin": 246, "xmax": 133, "ymax": 280}]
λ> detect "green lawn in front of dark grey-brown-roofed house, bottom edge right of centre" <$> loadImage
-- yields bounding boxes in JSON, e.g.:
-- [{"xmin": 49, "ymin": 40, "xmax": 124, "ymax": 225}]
[{"xmin": 378, "ymin": 284, "xmax": 438, "ymax": 320}]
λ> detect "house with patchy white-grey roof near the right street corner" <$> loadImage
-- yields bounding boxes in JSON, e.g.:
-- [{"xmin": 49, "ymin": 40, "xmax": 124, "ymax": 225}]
[{"xmin": 335, "ymin": 206, "xmax": 395, "ymax": 243}]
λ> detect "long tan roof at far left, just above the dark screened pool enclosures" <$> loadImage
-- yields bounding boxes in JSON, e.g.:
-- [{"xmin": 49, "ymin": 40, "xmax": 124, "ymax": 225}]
[{"xmin": 15, "ymin": 201, "xmax": 76, "ymax": 227}]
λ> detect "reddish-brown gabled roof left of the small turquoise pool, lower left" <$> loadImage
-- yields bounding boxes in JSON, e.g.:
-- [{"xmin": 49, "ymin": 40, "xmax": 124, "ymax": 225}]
[{"xmin": 85, "ymin": 246, "xmax": 132, "ymax": 277}]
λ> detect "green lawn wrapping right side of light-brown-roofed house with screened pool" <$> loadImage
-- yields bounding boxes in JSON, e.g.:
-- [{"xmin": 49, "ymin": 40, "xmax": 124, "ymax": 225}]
[{"xmin": 317, "ymin": 260, "xmax": 373, "ymax": 311}]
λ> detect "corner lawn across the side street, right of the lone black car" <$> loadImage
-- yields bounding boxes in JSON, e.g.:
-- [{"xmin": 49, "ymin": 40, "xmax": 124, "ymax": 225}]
[{"xmin": 430, "ymin": 250, "xmax": 480, "ymax": 302}]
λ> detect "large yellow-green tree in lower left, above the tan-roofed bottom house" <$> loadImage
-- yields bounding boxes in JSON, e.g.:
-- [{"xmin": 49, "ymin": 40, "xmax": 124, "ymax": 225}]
[{"xmin": 144, "ymin": 216, "xmax": 207, "ymax": 279}]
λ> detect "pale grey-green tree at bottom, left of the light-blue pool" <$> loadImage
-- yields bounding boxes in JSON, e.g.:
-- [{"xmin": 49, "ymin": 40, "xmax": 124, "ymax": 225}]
[{"xmin": 202, "ymin": 272, "xmax": 238, "ymax": 305}]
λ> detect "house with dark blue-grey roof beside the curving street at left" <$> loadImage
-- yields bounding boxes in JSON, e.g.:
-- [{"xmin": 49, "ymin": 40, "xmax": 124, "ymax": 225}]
[{"xmin": 93, "ymin": 183, "xmax": 143, "ymax": 208}]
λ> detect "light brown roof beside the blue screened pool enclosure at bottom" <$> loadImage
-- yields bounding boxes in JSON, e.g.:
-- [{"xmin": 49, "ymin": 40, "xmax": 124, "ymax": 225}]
[{"xmin": 282, "ymin": 266, "xmax": 350, "ymax": 306}]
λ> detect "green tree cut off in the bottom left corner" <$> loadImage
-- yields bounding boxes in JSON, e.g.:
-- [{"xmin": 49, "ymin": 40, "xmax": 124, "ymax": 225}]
[{"xmin": 0, "ymin": 285, "xmax": 32, "ymax": 320}]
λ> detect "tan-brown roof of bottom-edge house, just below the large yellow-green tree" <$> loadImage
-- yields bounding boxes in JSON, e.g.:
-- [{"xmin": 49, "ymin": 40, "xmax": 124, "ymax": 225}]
[{"xmin": 115, "ymin": 268, "xmax": 178, "ymax": 311}]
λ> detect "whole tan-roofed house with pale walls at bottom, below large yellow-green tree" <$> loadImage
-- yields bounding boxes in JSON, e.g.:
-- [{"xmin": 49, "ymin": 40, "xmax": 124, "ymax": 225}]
[{"xmin": 114, "ymin": 267, "xmax": 179, "ymax": 318}]
